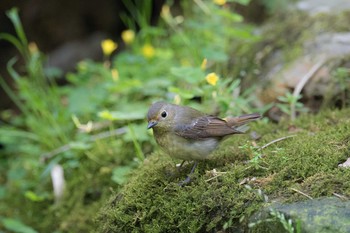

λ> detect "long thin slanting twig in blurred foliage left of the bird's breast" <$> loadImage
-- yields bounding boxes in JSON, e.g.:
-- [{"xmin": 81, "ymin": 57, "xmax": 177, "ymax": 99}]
[{"xmin": 40, "ymin": 127, "xmax": 126, "ymax": 162}]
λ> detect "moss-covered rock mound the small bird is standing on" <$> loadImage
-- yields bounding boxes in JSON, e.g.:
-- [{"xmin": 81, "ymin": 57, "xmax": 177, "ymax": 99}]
[{"xmin": 97, "ymin": 109, "xmax": 350, "ymax": 232}]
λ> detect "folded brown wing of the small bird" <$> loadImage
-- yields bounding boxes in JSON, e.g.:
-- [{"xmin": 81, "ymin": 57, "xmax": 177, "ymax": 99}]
[{"xmin": 175, "ymin": 116, "xmax": 242, "ymax": 139}]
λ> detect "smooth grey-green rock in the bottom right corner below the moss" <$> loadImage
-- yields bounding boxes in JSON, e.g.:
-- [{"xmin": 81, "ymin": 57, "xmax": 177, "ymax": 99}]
[{"xmin": 251, "ymin": 197, "xmax": 350, "ymax": 233}]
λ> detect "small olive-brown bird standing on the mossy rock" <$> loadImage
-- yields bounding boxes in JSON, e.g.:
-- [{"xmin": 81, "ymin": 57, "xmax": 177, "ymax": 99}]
[{"xmin": 147, "ymin": 102, "xmax": 261, "ymax": 184}]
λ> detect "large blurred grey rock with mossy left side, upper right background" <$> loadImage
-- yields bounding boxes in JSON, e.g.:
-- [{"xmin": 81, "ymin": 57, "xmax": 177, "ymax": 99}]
[{"xmin": 252, "ymin": 0, "xmax": 350, "ymax": 115}]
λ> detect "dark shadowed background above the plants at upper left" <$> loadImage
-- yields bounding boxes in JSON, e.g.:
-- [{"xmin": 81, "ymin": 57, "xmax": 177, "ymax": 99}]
[{"xmin": 0, "ymin": 0, "xmax": 170, "ymax": 110}]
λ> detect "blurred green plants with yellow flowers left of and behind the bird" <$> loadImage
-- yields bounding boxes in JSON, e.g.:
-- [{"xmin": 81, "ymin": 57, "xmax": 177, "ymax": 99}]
[{"xmin": 0, "ymin": 1, "xmax": 259, "ymax": 231}]
